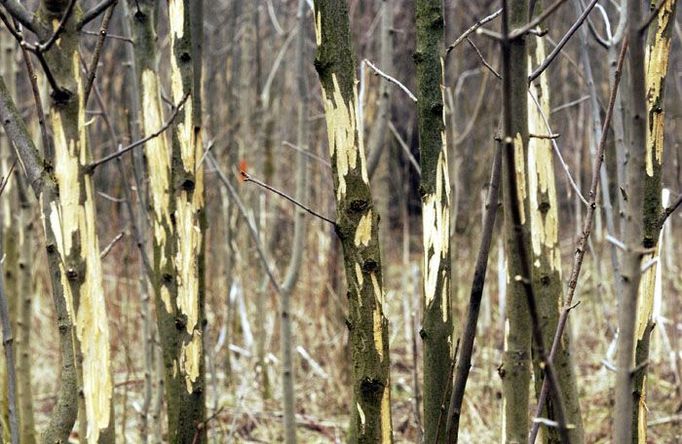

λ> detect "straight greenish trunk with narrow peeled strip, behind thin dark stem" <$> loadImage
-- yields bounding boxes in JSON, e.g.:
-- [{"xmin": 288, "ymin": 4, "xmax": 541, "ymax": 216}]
[{"xmin": 499, "ymin": 0, "xmax": 531, "ymax": 442}]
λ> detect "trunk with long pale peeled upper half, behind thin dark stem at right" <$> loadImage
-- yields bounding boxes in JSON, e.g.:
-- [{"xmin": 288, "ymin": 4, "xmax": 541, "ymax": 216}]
[{"xmin": 528, "ymin": 33, "xmax": 584, "ymax": 443}]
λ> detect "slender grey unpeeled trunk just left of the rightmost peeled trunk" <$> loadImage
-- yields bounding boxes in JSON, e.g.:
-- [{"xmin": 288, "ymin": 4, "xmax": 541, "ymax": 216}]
[{"xmin": 614, "ymin": 0, "xmax": 647, "ymax": 443}]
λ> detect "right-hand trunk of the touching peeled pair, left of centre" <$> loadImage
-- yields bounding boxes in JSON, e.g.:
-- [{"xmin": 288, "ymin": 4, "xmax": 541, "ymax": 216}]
[{"xmin": 161, "ymin": 0, "xmax": 206, "ymax": 443}]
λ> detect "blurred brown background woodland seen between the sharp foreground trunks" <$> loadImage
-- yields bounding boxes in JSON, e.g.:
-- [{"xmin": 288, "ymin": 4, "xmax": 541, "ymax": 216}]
[{"xmin": 0, "ymin": 0, "xmax": 682, "ymax": 443}]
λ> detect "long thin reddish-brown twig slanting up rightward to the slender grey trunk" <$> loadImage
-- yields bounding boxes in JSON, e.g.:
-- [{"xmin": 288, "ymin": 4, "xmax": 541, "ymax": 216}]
[{"xmin": 528, "ymin": 34, "xmax": 627, "ymax": 444}]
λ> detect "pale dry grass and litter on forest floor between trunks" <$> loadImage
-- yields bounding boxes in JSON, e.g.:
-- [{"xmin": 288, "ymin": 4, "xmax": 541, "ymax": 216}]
[{"xmin": 27, "ymin": 222, "xmax": 682, "ymax": 443}]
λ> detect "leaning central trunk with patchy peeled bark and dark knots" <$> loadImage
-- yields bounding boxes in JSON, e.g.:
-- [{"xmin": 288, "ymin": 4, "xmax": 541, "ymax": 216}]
[{"xmin": 315, "ymin": 0, "xmax": 393, "ymax": 444}]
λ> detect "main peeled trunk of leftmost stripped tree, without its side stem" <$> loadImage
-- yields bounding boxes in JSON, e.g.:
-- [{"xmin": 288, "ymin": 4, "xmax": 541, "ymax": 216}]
[{"xmin": 35, "ymin": 0, "xmax": 113, "ymax": 443}]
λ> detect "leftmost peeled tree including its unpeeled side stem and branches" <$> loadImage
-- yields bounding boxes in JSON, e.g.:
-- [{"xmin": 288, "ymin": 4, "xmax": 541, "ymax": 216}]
[{"xmin": 2, "ymin": 0, "xmax": 113, "ymax": 442}]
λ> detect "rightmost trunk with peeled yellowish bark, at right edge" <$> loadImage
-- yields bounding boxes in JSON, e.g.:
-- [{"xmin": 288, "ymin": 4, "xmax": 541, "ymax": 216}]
[{"xmin": 632, "ymin": 0, "xmax": 677, "ymax": 444}]
